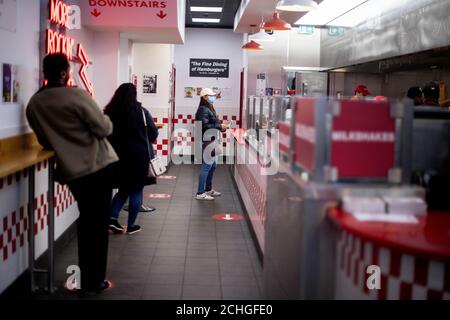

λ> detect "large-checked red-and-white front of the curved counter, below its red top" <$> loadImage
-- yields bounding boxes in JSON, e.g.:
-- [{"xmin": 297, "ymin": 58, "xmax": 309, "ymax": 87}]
[{"xmin": 336, "ymin": 230, "xmax": 450, "ymax": 300}]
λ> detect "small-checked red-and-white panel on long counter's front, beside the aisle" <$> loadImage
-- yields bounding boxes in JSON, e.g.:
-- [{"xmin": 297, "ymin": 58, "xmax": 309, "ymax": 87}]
[{"xmin": 237, "ymin": 165, "xmax": 267, "ymax": 226}]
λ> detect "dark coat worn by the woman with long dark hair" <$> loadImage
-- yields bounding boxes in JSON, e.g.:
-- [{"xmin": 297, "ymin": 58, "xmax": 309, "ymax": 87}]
[{"xmin": 109, "ymin": 104, "xmax": 159, "ymax": 191}]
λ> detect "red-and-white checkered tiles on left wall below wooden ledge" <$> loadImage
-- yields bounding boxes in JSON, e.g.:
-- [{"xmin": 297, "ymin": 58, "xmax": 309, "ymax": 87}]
[{"xmin": 0, "ymin": 162, "xmax": 75, "ymax": 261}]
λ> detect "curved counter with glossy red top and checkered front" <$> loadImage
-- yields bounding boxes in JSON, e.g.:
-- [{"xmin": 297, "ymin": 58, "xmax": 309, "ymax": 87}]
[{"xmin": 328, "ymin": 209, "xmax": 450, "ymax": 300}]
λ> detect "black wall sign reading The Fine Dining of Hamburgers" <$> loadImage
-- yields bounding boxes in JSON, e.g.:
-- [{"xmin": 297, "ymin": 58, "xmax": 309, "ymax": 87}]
[{"xmin": 190, "ymin": 59, "xmax": 230, "ymax": 78}]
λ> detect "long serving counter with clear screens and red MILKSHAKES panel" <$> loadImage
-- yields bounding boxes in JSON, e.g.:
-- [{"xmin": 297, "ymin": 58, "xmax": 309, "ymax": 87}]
[{"xmin": 233, "ymin": 97, "xmax": 448, "ymax": 299}]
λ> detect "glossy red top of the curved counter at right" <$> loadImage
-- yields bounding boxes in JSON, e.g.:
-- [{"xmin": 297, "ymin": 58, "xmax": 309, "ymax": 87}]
[{"xmin": 328, "ymin": 209, "xmax": 450, "ymax": 260}]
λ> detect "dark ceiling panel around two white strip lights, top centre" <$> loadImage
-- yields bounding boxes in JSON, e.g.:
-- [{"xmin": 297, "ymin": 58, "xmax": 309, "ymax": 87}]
[{"xmin": 186, "ymin": 0, "xmax": 241, "ymax": 29}]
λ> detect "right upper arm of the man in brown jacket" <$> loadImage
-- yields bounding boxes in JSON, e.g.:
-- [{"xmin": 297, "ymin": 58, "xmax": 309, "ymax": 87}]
[{"xmin": 75, "ymin": 92, "xmax": 113, "ymax": 139}]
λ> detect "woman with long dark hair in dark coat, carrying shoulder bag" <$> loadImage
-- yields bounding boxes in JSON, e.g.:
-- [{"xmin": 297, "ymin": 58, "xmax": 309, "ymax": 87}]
[{"xmin": 105, "ymin": 83, "xmax": 158, "ymax": 234}]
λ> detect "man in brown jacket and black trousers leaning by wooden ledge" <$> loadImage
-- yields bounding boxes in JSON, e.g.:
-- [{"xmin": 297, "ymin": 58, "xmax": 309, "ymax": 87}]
[{"xmin": 26, "ymin": 54, "xmax": 118, "ymax": 293}]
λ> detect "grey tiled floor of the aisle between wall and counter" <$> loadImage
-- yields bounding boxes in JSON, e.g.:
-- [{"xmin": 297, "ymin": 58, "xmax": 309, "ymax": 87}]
[{"xmin": 14, "ymin": 165, "xmax": 262, "ymax": 300}]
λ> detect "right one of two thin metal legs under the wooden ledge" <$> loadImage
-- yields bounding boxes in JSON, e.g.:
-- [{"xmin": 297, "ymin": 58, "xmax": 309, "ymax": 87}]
[{"xmin": 48, "ymin": 158, "xmax": 55, "ymax": 294}]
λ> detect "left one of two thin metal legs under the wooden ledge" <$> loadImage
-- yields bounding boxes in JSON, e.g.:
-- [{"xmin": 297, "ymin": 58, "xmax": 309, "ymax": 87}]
[{"xmin": 28, "ymin": 166, "xmax": 36, "ymax": 293}]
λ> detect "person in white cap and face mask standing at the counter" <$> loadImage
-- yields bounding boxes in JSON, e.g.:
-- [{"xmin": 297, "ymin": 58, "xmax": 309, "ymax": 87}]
[{"xmin": 195, "ymin": 88, "xmax": 229, "ymax": 201}]
